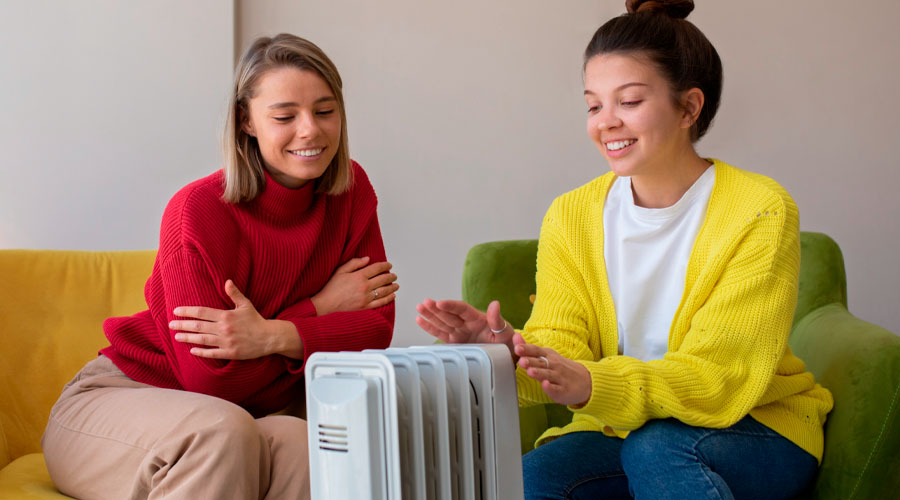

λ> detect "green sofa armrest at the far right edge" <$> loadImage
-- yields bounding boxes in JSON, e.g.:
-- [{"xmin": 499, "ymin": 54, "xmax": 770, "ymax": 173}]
[{"xmin": 790, "ymin": 303, "xmax": 900, "ymax": 499}]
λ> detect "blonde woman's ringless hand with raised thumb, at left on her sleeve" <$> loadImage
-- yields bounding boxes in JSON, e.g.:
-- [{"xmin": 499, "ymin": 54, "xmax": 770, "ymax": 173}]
[{"xmin": 169, "ymin": 280, "xmax": 303, "ymax": 359}]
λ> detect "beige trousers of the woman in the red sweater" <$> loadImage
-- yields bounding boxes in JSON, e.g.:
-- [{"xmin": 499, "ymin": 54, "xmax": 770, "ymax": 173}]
[{"xmin": 41, "ymin": 356, "xmax": 309, "ymax": 500}]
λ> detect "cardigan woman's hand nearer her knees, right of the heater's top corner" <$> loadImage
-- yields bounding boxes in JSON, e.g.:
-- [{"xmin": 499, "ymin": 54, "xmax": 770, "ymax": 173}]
[{"xmin": 513, "ymin": 333, "xmax": 593, "ymax": 406}]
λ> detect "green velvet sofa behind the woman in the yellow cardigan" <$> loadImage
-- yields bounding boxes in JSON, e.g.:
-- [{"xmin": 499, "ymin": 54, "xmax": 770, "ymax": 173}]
[{"xmin": 462, "ymin": 232, "xmax": 900, "ymax": 500}]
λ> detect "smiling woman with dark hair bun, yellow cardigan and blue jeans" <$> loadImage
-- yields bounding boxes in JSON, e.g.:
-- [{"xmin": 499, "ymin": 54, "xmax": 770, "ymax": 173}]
[{"xmin": 418, "ymin": 0, "xmax": 833, "ymax": 500}]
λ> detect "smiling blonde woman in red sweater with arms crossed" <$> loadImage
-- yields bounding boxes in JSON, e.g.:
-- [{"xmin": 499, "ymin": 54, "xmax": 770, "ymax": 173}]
[{"xmin": 42, "ymin": 34, "xmax": 398, "ymax": 499}]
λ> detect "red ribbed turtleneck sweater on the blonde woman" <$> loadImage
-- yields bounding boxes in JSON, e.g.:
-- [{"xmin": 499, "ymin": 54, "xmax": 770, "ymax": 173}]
[{"xmin": 101, "ymin": 162, "xmax": 394, "ymax": 415}]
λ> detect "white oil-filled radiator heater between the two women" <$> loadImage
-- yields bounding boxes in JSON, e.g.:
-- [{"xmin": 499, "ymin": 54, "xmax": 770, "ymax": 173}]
[{"xmin": 305, "ymin": 344, "xmax": 523, "ymax": 500}]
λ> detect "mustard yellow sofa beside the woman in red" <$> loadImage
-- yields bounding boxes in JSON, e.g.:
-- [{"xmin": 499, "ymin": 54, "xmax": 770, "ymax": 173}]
[{"xmin": 0, "ymin": 250, "xmax": 156, "ymax": 500}]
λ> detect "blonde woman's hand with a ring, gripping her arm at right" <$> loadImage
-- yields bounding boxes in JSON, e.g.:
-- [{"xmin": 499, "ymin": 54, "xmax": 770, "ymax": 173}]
[{"xmin": 310, "ymin": 257, "xmax": 400, "ymax": 316}]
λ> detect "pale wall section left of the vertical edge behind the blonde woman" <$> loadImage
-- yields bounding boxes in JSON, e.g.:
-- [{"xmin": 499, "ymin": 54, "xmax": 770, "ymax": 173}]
[{"xmin": 0, "ymin": 0, "xmax": 234, "ymax": 249}]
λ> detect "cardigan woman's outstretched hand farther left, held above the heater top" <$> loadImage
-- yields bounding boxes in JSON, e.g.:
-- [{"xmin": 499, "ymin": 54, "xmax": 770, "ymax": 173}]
[{"xmin": 416, "ymin": 299, "xmax": 515, "ymax": 355}]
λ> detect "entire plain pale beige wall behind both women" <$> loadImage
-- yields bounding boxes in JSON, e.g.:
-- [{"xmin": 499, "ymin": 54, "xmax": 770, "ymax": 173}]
[{"xmin": 0, "ymin": 0, "xmax": 900, "ymax": 345}]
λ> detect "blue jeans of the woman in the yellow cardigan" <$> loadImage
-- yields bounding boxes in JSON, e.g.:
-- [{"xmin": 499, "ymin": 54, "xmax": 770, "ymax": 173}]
[{"xmin": 522, "ymin": 416, "xmax": 818, "ymax": 500}]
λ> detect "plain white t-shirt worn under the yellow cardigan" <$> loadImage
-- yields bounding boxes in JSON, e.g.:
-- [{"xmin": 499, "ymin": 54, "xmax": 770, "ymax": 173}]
[{"xmin": 603, "ymin": 166, "xmax": 716, "ymax": 361}]
